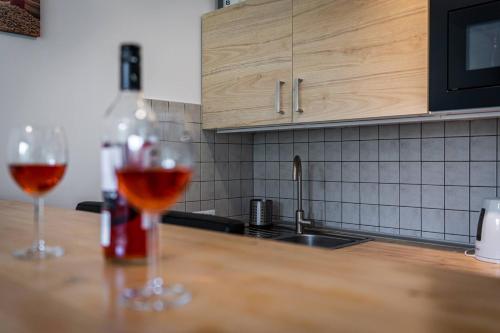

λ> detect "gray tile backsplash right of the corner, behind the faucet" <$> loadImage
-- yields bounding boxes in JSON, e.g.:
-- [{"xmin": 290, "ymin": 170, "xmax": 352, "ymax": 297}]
[{"xmin": 253, "ymin": 119, "xmax": 500, "ymax": 243}]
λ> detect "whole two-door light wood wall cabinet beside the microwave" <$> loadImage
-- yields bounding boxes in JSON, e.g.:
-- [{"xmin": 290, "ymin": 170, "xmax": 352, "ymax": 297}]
[{"xmin": 202, "ymin": 0, "xmax": 428, "ymax": 128}]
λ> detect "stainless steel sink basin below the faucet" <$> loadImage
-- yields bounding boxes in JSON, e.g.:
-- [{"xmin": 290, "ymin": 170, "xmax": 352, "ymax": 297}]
[{"xmin": 275, "ymin": 234, "xmax": 368, "ymax": 249}]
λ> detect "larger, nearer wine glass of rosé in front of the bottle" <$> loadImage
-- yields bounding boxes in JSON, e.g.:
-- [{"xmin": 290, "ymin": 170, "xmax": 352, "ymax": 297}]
[{"xmin": 116, "ymin": 113, "xmax": 193, "ymax": 311}]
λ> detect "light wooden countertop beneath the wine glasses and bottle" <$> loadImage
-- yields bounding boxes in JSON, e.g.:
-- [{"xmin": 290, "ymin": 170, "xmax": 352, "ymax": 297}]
[{"xmin": 0, "ymin": 201, "xmax": 500, "ymax": 332}]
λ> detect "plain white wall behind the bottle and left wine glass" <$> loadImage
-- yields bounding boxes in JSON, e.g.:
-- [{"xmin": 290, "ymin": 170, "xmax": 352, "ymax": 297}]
[{"xmin": 0, "ymin": 0, "xmax": 215, "ymax": 207}]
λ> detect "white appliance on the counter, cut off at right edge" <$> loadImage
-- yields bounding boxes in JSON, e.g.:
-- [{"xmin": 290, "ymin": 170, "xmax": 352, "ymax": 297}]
[{"xmin": 475, "ymin": 198, "xmax": 500, "ymax": 264}]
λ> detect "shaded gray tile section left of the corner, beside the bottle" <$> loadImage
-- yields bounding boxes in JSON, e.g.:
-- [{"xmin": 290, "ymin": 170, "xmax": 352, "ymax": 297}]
[{"xmin": 147, "ymin": 100, "xmax": 252, "ymax": 220}]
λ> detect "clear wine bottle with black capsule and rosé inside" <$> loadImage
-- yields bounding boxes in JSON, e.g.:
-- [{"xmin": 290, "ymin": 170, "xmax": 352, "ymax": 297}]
[{"xmin": 101, "ymin": 44, "xmax": 157, "ymax": 263}]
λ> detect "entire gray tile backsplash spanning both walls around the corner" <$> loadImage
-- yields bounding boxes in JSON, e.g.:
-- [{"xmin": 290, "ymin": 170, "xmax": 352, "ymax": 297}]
[{"xmin": 146, "ymin": 101, "xmax": 500, "ymax": 243}]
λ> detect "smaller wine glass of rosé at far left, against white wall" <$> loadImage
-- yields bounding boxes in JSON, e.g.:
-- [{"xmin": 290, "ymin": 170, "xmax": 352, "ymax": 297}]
[{"xmin": 7, "ymin": 125, "xmax": 68, "ymax": 260}]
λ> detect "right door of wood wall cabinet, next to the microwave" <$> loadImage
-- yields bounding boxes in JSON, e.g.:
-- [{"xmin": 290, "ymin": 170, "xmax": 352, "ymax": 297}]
[{"xmin": 293, "ymin": 0, "xmax": 428, "ymax": 122}]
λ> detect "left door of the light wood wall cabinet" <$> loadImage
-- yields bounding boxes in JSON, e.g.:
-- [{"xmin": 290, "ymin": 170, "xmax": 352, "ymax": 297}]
[{"xmin": 202, "ymin": 0, "xmax": 292, "ymax": 128}]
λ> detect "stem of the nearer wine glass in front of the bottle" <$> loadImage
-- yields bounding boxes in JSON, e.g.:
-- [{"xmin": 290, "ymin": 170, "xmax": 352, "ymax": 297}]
[{"xmin": 143, "ymin": 212, "xmax": 163, "ymax": 293}]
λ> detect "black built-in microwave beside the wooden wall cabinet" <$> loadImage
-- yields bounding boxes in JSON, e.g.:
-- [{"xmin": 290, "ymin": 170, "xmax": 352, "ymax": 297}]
[{"xmin": 429, "ymin": 0, "xmax": 500, "ymax": 112}]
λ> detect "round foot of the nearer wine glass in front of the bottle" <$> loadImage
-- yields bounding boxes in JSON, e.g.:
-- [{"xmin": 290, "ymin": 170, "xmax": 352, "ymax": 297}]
[{"xmin": 121, "ymin": 284, "xmax": 191, "ymax": 311}]
